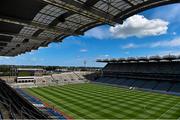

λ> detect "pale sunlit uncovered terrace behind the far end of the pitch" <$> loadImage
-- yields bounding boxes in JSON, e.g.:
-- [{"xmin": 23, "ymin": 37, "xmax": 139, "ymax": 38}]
[{"xmin": 8, "ymin": 71, "xmax": 91, "ymax": 88}]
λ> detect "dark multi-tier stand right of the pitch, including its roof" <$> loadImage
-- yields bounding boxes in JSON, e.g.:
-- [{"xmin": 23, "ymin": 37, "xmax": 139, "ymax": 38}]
[{"xmin": 93, "ymin": 55, "xmax": 180, "ymax": 95}]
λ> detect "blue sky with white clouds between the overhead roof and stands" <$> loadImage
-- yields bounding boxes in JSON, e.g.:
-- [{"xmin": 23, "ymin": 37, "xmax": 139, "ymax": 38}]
[{"xmin": 0, "ymin": 4, "xmax": 180, "ymax": 66}]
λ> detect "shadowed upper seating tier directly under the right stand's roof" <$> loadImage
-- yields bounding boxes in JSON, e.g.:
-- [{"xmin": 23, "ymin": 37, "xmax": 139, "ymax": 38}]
[{"xmin": 103, "ymin": 62, "xmax": 180, "ymax": 74}]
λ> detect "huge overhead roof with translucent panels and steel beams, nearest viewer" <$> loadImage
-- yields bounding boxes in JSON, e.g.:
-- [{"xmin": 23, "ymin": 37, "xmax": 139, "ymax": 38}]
[{"xmin": 0, "ymin": 0, "xmax": 180, "ymax": 56}]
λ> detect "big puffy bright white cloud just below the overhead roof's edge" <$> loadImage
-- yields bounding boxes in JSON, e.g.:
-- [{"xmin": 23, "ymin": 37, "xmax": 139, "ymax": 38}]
[{"xmin": 110, "ymin": 15, "xmax": 169, "ymax": 38}]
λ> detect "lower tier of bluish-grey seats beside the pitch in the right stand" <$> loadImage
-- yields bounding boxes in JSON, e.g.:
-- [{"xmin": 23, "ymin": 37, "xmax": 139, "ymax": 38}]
[{"xmin": 93, "ymin": 77, "xmax": 180, "ymax": 93}]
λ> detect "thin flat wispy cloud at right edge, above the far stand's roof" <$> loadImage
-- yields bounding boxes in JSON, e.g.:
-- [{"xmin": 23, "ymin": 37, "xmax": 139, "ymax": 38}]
[{"xmin": 150, "ymin": 38, "xmax": 180, "ymax": 47}]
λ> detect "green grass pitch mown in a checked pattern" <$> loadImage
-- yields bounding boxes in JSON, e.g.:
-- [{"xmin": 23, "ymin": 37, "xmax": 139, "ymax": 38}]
[{"xmin": 26, "ymin": 84, "xmax": 180, "ymax": 119}]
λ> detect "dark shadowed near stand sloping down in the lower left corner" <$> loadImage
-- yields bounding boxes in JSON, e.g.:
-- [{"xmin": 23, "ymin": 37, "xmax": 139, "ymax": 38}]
[{"xmin": 0, "ymin": 80, "xmax": 49, "ymax": 119}]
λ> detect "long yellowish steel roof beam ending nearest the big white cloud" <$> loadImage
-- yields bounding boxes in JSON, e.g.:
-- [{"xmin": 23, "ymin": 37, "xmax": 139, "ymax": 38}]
[{"xmin": 42, "ymin": 0, "xmax": 115, "ymax": 24}]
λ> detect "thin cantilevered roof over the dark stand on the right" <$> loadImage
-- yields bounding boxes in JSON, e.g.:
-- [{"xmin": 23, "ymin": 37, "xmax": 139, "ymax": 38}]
[{"xmin": 96, "ymin": 55, "xmax": 180, "ymax": 63}]
